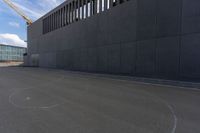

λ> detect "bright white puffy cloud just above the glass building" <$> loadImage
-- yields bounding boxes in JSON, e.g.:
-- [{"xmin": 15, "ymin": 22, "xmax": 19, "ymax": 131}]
[{"xmin": 0, "ymin": 33, "xmax": 27, "ymax": 47}]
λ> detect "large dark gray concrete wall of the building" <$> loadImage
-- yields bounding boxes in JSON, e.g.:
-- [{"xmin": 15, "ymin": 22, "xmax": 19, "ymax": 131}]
[{"xmin": 28, "ymin": 0, "xmax": 200, "ymax": 81}]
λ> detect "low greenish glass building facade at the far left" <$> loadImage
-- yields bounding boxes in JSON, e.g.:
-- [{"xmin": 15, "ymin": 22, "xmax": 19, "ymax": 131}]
[{"xmin": 0, "ymin": 44, "xmax": 26, "ymax": 62}]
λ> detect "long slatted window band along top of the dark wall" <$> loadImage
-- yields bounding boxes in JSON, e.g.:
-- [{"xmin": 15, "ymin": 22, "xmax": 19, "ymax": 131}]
[{"xmin": 43, "ymin": 0, "xmax": 129, "ymax": 34}]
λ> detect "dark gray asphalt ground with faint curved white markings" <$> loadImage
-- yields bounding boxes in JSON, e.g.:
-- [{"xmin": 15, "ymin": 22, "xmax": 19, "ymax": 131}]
[{"xmin": 0, "ymin": 67, "xmax": 200, "ymax": 133}]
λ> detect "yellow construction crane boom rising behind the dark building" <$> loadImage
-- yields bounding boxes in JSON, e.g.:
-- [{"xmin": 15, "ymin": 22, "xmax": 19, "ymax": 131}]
[{"xmin": 3, "ymin": 0, "xmax": 33, "ymax": 25}]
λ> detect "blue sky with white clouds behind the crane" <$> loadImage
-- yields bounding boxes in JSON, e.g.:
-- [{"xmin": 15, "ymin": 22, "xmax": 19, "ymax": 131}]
[{"xmin": 0, "ymin": 0, "xmax": 65, "ymax": 47}]
